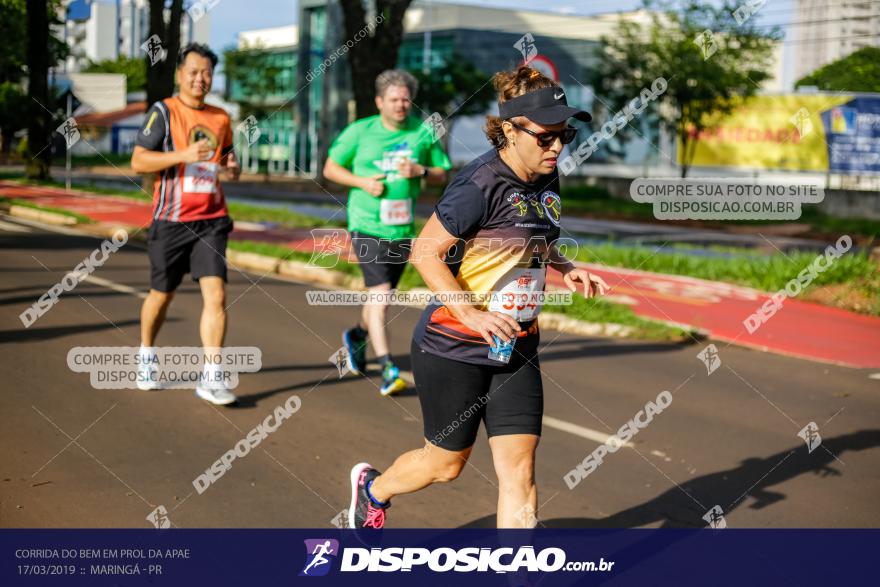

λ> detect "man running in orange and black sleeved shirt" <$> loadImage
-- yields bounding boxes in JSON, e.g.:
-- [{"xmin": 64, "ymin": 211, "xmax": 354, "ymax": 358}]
[{"xmin": 131, "ymin": 43, "xmax": 240, "ymax": 405}]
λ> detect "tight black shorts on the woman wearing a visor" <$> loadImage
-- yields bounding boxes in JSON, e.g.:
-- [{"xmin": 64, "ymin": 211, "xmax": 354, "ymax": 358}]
[{"xmin": 410, "ymin": 341, "xmax": 544, "ymax": 451}]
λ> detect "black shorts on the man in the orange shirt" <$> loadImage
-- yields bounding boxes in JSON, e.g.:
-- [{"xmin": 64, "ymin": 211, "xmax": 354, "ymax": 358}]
[{"xmin": 147, "ymin": 216, "xmax": 232, "ymax": 292}]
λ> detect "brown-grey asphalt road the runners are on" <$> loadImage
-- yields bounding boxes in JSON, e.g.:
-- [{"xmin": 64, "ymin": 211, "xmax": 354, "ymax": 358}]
[{"xmin": 0, "ymin": 218, "xmax": 880, "ymax": 528}]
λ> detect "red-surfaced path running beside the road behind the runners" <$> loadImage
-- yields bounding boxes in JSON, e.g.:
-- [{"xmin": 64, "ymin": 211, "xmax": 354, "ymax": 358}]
[{"xmin": 6, "ymin": 181, "xmax": 880, "ymax": 369}]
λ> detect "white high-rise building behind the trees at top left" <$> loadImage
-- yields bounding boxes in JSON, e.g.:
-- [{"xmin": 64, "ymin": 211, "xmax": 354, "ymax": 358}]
[{"xmin": 56, "ymin": 0, "xmax": 211, "ymax": 72}]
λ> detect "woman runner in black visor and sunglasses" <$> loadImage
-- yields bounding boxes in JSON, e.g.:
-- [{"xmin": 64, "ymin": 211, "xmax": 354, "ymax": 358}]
[{"xmin": 348, "ymin": 66, "xmax": 607, "ymax": 528}]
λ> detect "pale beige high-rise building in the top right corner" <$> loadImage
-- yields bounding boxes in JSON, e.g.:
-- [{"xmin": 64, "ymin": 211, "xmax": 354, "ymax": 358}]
[{"xmin": 794, "ymin": 0, "xmax": 880, "ymax": 80}]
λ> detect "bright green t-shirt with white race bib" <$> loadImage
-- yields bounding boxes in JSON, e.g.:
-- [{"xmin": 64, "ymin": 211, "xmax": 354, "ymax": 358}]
[{"xmin": 328, "ymin": 114, "xmax": 452, "ymax": 239}]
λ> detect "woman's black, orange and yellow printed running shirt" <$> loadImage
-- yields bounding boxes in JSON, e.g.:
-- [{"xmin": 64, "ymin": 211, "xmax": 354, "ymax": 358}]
[{"xmin": 414, "ymin": 151, "xmax": 562, "ymax": 365}]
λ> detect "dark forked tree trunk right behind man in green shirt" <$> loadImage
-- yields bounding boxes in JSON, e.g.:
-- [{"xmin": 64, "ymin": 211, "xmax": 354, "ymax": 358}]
[{"xmin": 340, "ymin": 0, "xmax": 412, "ymax": 118}]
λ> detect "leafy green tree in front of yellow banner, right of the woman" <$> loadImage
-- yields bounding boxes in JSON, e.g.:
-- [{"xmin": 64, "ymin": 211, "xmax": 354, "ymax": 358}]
[{"xmin": 590, "ymin": 0, "xmax": 781, "ymax": 177}]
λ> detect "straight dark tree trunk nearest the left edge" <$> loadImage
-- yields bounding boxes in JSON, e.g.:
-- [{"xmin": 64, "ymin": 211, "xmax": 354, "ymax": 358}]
[{"xmin": 26, "ymin": 0, "xmax": 53, "ymax": 179}]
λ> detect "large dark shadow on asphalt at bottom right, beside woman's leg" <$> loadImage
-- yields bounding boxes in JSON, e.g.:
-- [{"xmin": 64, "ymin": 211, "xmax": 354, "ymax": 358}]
[{"xmin": 462, "ymin": 429, "xmax": 880, "ymax": 528}]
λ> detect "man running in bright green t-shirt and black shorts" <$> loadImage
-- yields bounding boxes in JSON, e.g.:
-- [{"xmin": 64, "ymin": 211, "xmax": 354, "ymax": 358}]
[{"xmin": 324, "ymin": 70, "xmax": 452, "ymax": 395}]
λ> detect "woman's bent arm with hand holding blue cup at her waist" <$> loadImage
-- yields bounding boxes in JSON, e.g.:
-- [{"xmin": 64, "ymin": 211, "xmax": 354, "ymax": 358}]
[{"xmin": 410, "ymin": 214, "xmax": 520, "ymax": 345}]
